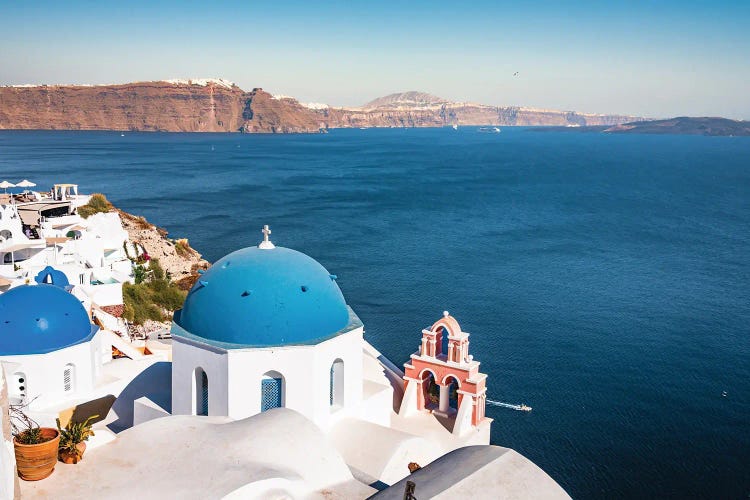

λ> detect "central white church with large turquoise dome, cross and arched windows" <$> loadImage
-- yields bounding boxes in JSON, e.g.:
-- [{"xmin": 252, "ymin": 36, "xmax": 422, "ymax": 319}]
[{"xmin": 172, "ymin": 227, "xmax": 370, "ymax": 429}]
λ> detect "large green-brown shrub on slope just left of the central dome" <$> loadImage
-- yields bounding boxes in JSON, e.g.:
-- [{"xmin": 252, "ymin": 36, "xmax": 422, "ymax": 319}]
[{"xmin": 122, "ymin": 259, "xmax": 186, "ymax": 324}]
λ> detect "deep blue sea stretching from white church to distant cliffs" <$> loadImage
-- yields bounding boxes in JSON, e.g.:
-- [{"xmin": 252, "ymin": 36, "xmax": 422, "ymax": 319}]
[{"xmin": 0, "ymin": 127, "xmax": 750, "ymax": 498}]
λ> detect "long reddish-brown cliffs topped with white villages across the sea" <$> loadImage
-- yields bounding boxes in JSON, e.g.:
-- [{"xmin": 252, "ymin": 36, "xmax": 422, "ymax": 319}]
[{"xmin": 0, "ymin": 78, "xmax": 642, "ymax": 133}]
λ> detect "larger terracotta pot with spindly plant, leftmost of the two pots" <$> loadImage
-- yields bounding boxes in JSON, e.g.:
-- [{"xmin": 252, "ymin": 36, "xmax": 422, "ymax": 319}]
[{"xmin": 8, "ymin": 405, "xmax": 60, "ymax": 481}]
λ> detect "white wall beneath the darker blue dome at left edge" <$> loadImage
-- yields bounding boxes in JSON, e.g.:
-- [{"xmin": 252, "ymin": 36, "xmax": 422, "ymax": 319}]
[{"xmin": 0, "ymin": 333, "xmax": 100, "ymax": 410}]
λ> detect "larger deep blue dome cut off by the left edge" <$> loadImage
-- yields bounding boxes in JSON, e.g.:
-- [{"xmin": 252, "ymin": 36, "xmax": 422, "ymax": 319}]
[{"xmin": 0, "ymin": 284, "xmax": 98, "ymax": 356}]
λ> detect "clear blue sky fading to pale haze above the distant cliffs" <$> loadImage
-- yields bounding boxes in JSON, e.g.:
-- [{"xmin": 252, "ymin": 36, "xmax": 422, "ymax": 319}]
[{"xmin": 0, "ymin": 0, "xmax": 750, "ymax": 119}]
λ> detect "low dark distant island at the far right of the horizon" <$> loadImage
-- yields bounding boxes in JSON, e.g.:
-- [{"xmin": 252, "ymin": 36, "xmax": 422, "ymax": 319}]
[{"xmin": 534, "ymin": 116, "xmax": 750, "ymax": 136}]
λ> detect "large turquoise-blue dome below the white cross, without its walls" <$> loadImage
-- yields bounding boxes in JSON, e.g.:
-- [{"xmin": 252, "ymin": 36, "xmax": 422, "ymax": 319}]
[{"xmin": 175, "ymin": 247, "xmax": 349, "ymax": 347}]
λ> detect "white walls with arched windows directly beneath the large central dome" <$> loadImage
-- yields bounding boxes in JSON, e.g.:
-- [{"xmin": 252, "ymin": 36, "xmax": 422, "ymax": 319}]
[{"xmin": 172, "ymin": 327, "xmax": 363, "ymax": 429}]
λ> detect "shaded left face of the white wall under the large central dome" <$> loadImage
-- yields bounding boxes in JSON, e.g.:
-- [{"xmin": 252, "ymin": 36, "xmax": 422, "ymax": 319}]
[{"xmin": 172, "ymin": 337, "xmax": 229, "ymax": 415}]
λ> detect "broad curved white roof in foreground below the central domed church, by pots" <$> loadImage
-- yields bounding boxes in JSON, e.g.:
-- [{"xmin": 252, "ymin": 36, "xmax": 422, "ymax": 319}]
[{"xmin": 23, "ymin": 408, "xmax": 375, "ymax": 500}]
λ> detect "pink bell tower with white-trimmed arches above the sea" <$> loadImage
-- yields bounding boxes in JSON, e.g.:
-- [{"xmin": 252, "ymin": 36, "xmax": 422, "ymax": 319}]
[{"xmin": 399, "ymin": 311, "xmax": 489, "ymax": 434}]
